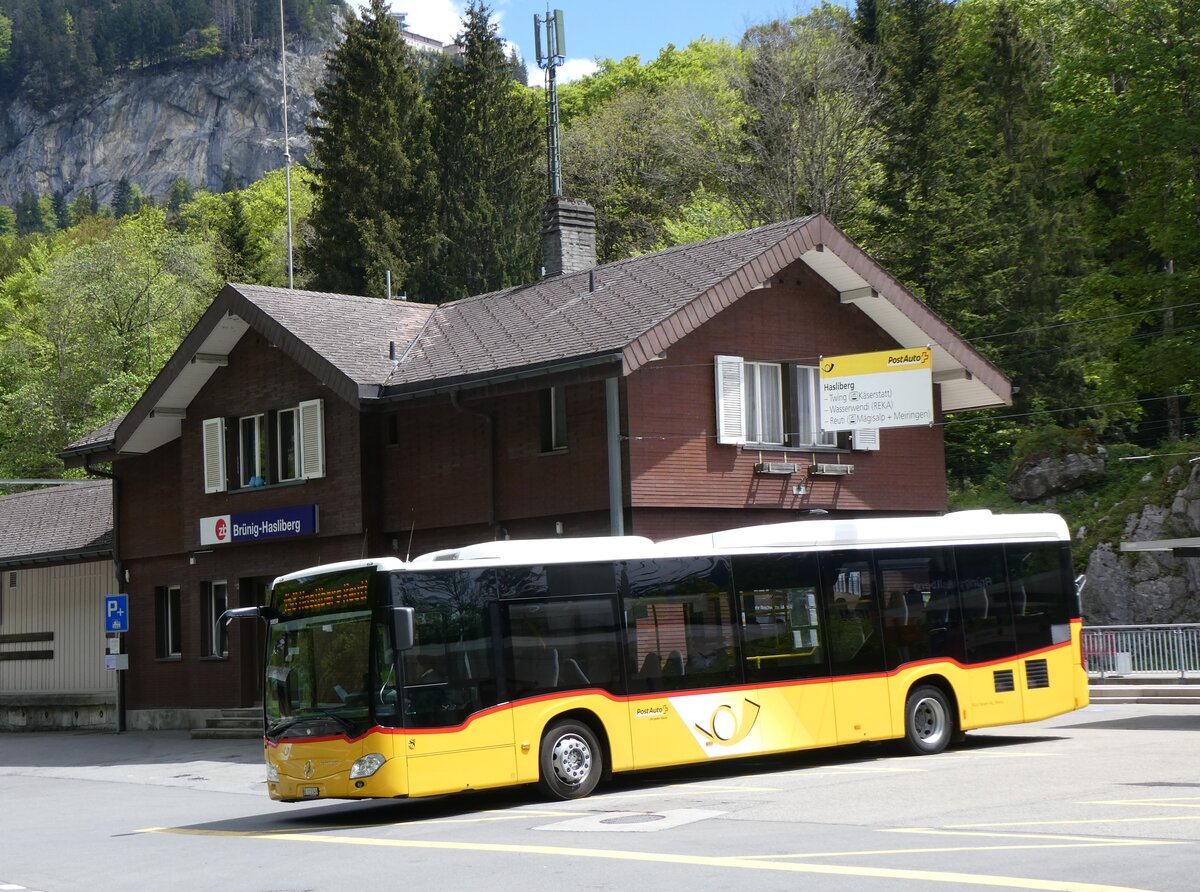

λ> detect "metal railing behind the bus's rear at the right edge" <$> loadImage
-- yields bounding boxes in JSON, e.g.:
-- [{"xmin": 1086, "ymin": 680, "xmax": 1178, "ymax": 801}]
[{"xmin": 1084, "ymin": 623, "xmax": 1200, "ymax": 680}]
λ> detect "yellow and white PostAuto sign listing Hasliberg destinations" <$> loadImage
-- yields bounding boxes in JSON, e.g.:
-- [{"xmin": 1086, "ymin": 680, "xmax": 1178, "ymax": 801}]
[{"xmin": 821, "ymin": 347, "xmax": 934, "ymax": 431}]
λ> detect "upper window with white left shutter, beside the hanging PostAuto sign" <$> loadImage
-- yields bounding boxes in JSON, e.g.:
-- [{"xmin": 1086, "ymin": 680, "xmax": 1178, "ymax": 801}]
[{"xmin": 716, "ymin": 357, "xmax": 839, "ymax": 448}]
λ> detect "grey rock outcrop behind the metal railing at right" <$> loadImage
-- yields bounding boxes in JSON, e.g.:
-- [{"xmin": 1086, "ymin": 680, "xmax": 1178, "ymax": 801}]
[{"xmin": 1084, "ymin": 465, "xmax": 1200, "ymax": 625}]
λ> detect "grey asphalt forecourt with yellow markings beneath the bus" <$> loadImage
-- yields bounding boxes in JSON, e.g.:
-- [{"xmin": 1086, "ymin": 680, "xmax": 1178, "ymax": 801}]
[{"xmin": 0, "ymin": 705, "xmax": 1200, "ymax": 892}]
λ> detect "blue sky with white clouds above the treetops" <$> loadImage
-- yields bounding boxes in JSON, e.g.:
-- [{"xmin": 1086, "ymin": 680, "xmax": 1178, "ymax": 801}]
[{"xmin": 379, "ymin": 0, "xmax": 812, "ymax": 84}]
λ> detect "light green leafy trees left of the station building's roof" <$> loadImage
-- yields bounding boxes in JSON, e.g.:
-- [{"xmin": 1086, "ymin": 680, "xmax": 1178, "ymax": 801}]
[{"xmin": 0, "ymin": 209, "xmax": 218, "ymax": 477}]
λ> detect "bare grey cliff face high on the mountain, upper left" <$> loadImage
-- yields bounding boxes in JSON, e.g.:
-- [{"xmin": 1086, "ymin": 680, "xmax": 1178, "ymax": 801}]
[{"xmin": 0, "ymin": 43, "xmax": 329, "ymax": 205}]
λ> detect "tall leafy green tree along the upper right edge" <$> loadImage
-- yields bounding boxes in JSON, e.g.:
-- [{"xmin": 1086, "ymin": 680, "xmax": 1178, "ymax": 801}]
[{"xmin": 1052, "ymin": 0, "xmax": 1200, "ymax": 444}]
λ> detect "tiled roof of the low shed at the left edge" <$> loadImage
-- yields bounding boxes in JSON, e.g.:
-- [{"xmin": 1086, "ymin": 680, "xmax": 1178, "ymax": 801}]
[{"xmin": 0, "ymin": 480, "xmax": 113, "ymax": 567}]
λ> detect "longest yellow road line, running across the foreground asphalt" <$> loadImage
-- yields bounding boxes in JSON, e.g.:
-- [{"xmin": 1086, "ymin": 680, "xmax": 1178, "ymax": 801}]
[{"xmin": 140, "ymin": 827, "xmax": 1161, "ymax": 892}]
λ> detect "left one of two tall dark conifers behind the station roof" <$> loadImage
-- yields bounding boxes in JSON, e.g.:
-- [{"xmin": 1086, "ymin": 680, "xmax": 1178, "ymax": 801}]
[{"xmin": 305, "ymin": 0, "xmax": 441, "ymax": 300}]
